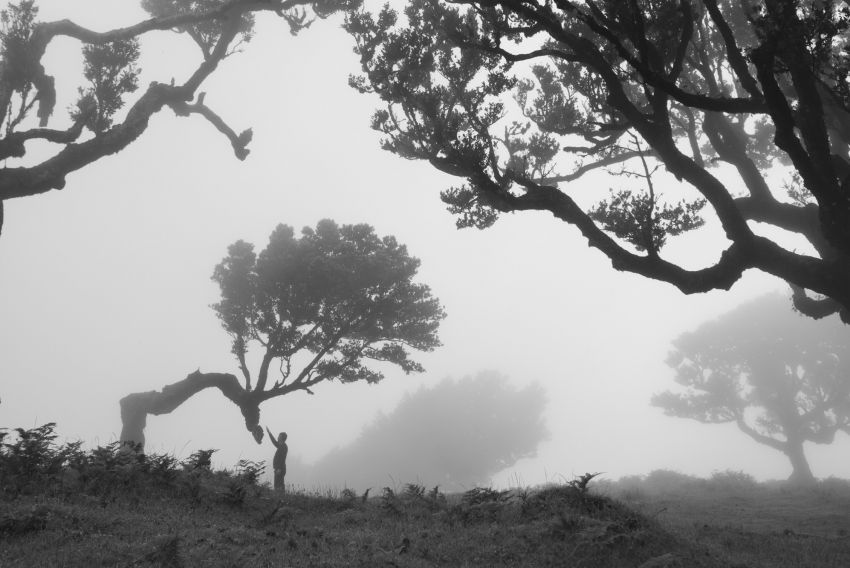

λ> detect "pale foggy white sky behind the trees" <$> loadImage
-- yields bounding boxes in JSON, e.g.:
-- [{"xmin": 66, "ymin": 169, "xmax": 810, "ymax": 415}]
[{"xmin": 0, "ymin": 0, "xmax": 850, "ymax": 484}]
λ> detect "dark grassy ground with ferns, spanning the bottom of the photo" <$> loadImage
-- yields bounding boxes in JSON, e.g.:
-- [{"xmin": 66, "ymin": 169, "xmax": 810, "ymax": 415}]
[{"xmin": 0, "ymin": 424, "xmax": 850, "ymax": 568}]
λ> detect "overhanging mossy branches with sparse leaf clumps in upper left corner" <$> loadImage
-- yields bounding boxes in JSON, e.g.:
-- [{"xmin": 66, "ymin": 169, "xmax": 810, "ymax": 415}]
[{"xmin": 0, "ymin": 0, "xmax": 357, "ymax": 230}]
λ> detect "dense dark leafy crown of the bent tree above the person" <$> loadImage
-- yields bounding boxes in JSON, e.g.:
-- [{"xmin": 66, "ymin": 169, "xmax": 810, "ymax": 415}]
[{"xmin": 213, "ymin": 219, "xmax": 444, "ymax": 385}]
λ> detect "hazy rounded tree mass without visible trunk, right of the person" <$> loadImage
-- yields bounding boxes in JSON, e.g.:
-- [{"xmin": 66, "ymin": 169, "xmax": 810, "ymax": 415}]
[{"xmin": 304, "ymin": 372, "xmax": 547, "ymax": 490}]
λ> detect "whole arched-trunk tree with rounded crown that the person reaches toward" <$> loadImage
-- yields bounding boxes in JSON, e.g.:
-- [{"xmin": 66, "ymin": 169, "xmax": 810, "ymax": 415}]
[{"xmin": 121, "ymin": 220, "xmax": 445, "ymax": 445}]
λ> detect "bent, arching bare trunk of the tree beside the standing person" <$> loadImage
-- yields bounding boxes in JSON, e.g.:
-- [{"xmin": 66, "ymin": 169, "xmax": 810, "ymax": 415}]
[{"xmin": 120, "ymin": 370, "xmax": 263, "ymax": 449}]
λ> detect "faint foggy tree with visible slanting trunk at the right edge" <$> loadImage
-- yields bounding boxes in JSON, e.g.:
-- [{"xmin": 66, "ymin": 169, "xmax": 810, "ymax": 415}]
[{"xmin": 652, "ymin": 295, "xmax": 850, "ymax": 482}]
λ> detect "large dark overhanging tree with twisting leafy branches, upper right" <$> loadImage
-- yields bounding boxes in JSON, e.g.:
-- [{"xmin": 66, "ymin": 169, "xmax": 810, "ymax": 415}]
[{"xmin": 346, "ymin": 0, "xmax": 850, "ymax": 322}]
